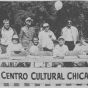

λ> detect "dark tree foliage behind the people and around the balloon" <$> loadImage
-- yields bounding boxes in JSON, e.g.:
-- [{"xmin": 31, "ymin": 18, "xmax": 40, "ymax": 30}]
[{"xmin": 0, "ymin": 1, "xmax": 88, "ymax": 37}]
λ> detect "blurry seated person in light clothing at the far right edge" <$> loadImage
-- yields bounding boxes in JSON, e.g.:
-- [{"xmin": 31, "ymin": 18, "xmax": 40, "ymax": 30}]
[{"xmin": 74, "ymin": 37, "xmax": 88, "ymax": 55}]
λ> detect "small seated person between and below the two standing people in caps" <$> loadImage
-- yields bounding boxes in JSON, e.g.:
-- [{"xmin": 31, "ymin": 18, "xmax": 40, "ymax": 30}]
[{"xmin": 27, "ymin": 37, "xmax": 43, "ymax": 56}]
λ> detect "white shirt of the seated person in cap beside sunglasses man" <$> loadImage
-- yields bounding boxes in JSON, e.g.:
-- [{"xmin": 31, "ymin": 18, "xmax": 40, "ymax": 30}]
[{"xmin": 53, "ymin": 44, "xmax": 69, "ymax": 56}]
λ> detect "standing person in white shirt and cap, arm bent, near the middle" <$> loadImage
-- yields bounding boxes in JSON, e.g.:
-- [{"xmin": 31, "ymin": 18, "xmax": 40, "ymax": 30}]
[{"xmin": 39, "ymin": 23, "xmax": 56, "ymax": 51}]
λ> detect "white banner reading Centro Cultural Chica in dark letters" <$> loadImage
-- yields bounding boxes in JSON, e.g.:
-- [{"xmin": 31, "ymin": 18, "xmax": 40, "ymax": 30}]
[{"xmin": 0, "ymin": 68, "xmax": 88, "ymax": 84}]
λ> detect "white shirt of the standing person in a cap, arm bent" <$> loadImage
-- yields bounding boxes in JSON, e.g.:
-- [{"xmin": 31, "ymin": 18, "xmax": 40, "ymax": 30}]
[{"xmin": 39, "ymin": 30, "xmax": 56, "ymax": 49}]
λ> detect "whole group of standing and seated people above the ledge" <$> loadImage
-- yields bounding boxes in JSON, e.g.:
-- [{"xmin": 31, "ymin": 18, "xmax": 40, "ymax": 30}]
[{"xmin": 0, "ymin": 17, "xmax": 88, "ymax": 57}]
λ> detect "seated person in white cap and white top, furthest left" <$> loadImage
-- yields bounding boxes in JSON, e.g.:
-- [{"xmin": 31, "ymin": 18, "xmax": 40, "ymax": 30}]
[{"xmin": 7, "ymin": 35, "xmax": 25, "ymax": 56}]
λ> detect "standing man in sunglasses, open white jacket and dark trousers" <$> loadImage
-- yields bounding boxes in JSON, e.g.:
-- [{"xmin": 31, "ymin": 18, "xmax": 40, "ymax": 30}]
[{"xmin": 62, "ymin": 20, "xmax": 78, "ymax": 51}]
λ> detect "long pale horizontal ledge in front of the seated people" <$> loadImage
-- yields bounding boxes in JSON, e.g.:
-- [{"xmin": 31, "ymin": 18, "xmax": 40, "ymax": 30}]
[{"xmin": 0, "ymin": 55, "xmax": 88, "ymax": 62}]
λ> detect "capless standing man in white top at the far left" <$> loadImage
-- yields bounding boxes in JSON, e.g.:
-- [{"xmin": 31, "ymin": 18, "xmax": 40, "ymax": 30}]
[{"xmin": 0, "ymin": 19, "xmax": 17, "ymax": 54}]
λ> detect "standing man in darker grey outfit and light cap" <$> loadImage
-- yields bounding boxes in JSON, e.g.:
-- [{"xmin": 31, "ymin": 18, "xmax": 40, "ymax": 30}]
[{"xmin": 19, "ymin": 17, "xmax": 36, "ymax": 48}]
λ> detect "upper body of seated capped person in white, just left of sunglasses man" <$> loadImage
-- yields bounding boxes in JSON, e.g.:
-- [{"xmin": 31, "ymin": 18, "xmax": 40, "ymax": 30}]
[{"xmin": 53, "ymin": 36, "xmax": 69, "ymax": 57}]
